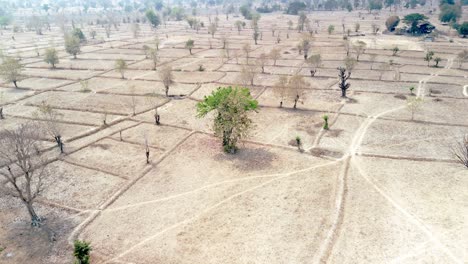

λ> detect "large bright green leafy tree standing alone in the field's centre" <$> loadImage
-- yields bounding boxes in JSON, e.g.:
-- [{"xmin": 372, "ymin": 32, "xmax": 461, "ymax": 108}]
[{"xmin": 197, "ymin": 86, "xmax": 258, "ymax": 153}]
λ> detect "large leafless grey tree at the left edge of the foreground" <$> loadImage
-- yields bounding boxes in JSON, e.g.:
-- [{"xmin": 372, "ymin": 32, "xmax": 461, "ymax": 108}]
[{"xmin": 0, "ymin": 123, "xmax": 47, "ymax": 226}]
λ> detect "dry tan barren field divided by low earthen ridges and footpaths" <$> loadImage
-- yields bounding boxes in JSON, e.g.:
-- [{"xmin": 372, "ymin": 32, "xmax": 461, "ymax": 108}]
[{"xmin": 0, "ymin": 6, "xmax": 468, "ymax": 264}]
